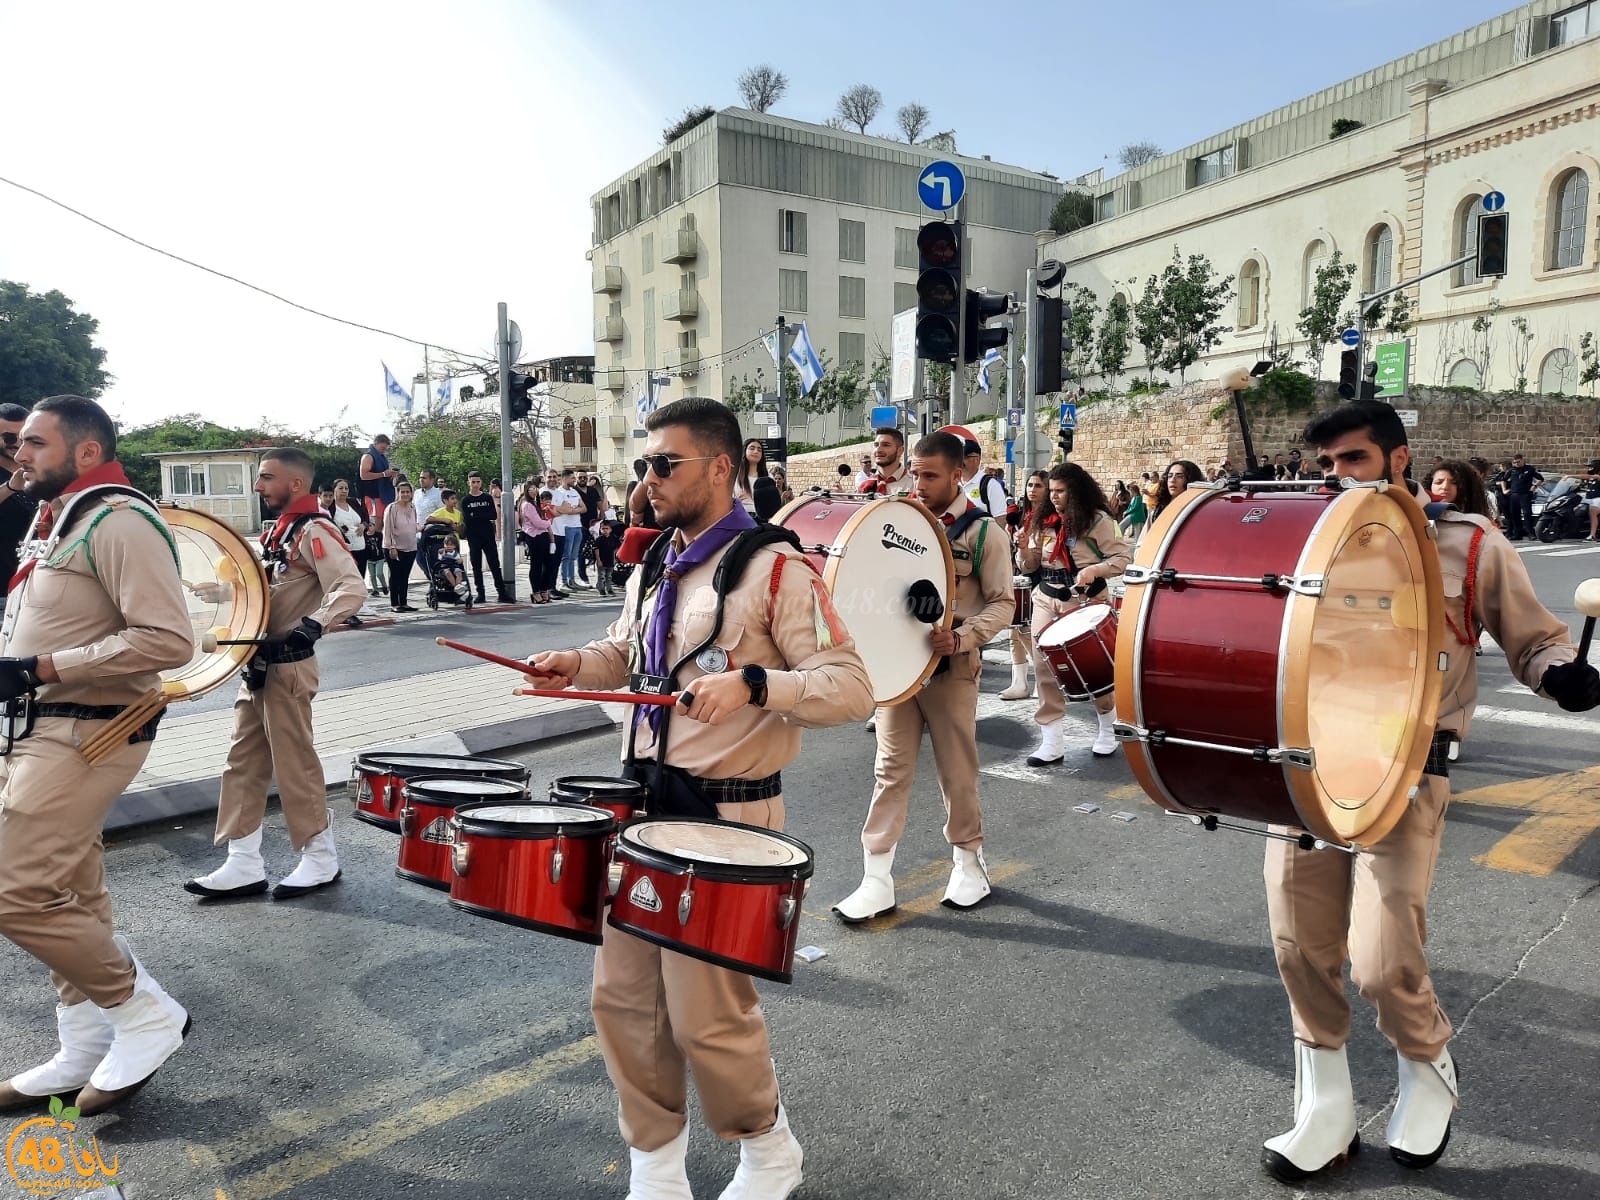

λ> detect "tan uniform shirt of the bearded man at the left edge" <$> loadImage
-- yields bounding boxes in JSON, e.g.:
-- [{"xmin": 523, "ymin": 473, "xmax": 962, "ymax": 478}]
[{"xmin": 5, "ymin": 496, "xmax": 195, "ymax": 704}]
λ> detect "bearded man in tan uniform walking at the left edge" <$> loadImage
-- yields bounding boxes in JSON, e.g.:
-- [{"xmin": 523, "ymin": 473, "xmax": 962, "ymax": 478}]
[{"xmin": 0, "ymin": 395, "xmax": 194, "ymax": 1117}]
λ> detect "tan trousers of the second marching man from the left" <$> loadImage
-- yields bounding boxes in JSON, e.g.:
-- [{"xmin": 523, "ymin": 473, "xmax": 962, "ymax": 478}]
[{"xmin": 216, "ymin": 658, "xmax": 328, "ymax": 850}]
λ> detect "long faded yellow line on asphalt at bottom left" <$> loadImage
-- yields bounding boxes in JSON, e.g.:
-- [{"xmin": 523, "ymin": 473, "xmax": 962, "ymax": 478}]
[{"xmin": 234, "ymin": 1034, "xmax": 600, "ymax": 1200}]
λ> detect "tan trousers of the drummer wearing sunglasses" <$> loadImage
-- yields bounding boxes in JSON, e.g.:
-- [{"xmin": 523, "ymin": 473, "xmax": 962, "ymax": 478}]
[{"xmin": 590, "ymin": 797, "xmax": 784, "ymax": 1152}]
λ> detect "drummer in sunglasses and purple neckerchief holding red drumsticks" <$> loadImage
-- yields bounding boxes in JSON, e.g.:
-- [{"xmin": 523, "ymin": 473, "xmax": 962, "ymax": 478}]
[{"xmin": 530, "ymin": 397, "xmax": 872, "ymax": 1200}]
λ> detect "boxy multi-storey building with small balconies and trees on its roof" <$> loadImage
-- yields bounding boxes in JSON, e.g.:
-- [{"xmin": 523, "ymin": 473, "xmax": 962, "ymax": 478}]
[{"xmin": 590, "ymin": 109, "xmax": 1061, "ymax": 458}]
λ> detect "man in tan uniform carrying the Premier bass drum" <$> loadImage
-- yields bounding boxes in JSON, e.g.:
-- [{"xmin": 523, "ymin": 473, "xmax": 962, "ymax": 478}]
[{"xmin": 834, "ymin": 432, "xmax": 1016, "ymax": 925}]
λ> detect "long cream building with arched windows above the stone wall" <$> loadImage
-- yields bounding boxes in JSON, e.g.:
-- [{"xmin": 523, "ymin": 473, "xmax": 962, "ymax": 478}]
[{"xmin": 1043, "ymin": 0, "xmax": 1600, "ymax": 395}]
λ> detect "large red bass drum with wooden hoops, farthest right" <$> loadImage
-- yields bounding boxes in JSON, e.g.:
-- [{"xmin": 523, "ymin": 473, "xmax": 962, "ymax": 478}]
[{"xmin": 1117, "ymin": 485, "xmax": 1445, "ymax": 848}]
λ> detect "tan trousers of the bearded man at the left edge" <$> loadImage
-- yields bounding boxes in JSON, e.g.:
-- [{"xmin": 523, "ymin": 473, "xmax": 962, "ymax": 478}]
[{"xmin": 0, "ymin": 717, "xmax": 150, "ymax": 1008}]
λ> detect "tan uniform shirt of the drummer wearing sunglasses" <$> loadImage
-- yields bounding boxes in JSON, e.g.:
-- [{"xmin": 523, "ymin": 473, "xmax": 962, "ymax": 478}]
[{"xmin": 573, "ymin": 528, "xmax": 876, "ymax": 779}]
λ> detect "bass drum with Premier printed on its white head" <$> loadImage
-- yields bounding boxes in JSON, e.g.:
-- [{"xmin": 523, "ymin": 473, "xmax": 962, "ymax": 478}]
[{"xmin": 773, "ymin": 494, "xmax": 955, "ymax": 704}]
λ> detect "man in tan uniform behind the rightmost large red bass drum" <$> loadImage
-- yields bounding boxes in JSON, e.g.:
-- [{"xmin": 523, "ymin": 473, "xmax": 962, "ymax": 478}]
[{"xmin": 1262, "ymin": 400, "xmax": 1600, "ymax": 1182}]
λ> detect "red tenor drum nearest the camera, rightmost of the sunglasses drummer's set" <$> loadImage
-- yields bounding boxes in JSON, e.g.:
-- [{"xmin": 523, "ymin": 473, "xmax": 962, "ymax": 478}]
[{"xmin": 608, "ymin": 818, "xmax": 811, "ymax": 984}]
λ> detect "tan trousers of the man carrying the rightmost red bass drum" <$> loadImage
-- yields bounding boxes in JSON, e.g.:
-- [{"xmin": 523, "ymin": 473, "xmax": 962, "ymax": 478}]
[{"xmin": 1266, "ymin": 774, "xmax": 1450, "ymax": 1062}]
